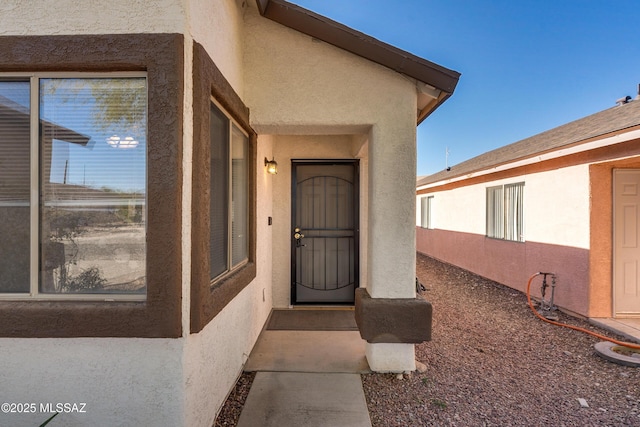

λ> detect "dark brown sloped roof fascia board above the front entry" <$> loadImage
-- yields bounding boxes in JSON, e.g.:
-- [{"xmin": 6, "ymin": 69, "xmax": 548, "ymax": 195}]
[{"xmin": 256, "ymin": 0, "xmax": 460, "ymax": 95}]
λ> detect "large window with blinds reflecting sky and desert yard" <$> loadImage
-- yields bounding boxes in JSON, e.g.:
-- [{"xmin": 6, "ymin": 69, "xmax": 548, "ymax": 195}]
[{"xmin": 0, "ymin": 73, "xmax": 147, "ymax": 299}]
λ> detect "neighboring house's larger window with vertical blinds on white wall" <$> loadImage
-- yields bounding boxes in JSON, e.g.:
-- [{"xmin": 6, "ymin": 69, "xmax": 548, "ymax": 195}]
[{"xmin": 487, "ymin": 182, "xmax": 524, "ymax": 242}]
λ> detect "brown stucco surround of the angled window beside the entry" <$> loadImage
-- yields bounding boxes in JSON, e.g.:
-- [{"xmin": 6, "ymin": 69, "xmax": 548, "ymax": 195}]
[{"xmin": 190, "ymin": 43, "xmax": 257, "ymax": 333}]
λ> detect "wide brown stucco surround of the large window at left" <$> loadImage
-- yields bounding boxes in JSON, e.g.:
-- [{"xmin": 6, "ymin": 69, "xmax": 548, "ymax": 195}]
[{"xmin": 0, "ymin": 34, "xmax": 184, "ymax": 337}]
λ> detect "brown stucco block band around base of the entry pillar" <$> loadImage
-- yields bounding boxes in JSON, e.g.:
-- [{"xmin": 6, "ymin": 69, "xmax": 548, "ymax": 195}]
[{"xmin": 355, "ymin": 288, "xmax": 433, "ymax": 344}]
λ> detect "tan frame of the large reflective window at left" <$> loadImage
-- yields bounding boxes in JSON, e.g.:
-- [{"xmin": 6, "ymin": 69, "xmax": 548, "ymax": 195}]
[{"xmin": 0, "ymin": 71, "xmax": 149, "ymax": 301}]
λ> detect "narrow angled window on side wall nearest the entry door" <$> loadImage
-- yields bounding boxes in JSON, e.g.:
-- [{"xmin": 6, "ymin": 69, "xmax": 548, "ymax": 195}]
[{"xmin": 209, "ymin": 102, "xmax": 249, "ymax": 279}]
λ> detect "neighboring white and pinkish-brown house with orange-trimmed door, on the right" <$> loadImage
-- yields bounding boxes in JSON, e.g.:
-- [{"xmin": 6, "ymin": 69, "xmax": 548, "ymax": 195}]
[{"xmin": 416, "ymin": 96, "xmax": 640, "ymax": 317}]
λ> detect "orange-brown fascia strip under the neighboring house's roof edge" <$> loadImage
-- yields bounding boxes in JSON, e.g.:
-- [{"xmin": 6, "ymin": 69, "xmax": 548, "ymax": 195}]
[{"xmin": 416, "ymin": 139, "xmax": 640, "ymax": 195}]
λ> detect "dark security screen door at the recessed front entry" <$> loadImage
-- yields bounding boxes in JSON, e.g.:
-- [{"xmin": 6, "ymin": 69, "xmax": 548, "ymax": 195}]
[{"xmin": 291, "ymin": 161, "xmax": 358, "ymax": 304}]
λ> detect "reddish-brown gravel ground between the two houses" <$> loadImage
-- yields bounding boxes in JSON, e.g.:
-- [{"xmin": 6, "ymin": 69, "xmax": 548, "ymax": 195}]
[{"xmin": 215, "ymin": 255, "xmax": 640, "ymax": 427}]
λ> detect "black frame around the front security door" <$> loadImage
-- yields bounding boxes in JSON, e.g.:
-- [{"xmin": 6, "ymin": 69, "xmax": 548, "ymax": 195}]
[{"xmin": 289, "ymin": 159, "xmax": 360, "ymax": 306}]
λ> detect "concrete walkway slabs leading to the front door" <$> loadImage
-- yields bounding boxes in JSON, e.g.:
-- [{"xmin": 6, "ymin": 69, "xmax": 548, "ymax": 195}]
[{"xmin": 238, "ymin": 330, "xmax": 371, "ymax": 427}]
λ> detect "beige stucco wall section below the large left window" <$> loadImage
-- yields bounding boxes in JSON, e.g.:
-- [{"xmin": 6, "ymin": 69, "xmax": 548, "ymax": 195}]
[{"xmin": 0, "ymin": 338, "xmax": 184, "ymax": 427}]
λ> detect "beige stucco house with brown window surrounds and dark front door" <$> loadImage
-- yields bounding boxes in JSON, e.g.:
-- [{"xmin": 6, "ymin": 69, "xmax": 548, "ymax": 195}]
[{"xmin": 0, "ymin": 0, "xmax": 459, "ymax": 426}]
